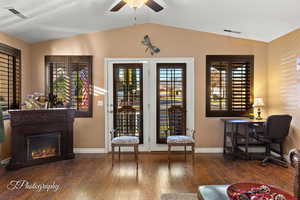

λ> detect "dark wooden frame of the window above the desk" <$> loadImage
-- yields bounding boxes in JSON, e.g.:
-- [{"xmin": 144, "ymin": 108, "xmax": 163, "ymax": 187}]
[{"xmin": 206, "ymin": 55, "xmax": 254, "ymax": 117}]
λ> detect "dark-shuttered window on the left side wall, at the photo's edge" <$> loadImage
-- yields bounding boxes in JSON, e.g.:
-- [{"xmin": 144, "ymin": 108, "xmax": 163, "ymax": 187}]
[{"xmin": 0, "ymin": 44, "xmax": 21, "ymax": 111}]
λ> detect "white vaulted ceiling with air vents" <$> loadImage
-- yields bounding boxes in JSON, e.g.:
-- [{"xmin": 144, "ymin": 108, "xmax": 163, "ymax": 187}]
[{"xmin": 0, "ymin": 0, "xmax": 300, "ymax": 42}]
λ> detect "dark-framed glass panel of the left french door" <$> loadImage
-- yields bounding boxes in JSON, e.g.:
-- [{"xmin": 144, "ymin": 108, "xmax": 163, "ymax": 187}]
[{"xmin": 113, "ymin": 64, "xmax": 143, "ymax": 144}]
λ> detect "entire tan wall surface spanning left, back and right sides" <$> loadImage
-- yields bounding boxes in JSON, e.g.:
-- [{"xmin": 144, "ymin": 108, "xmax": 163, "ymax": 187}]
[{"xmin": 0, "ymin": 24, "xmax": 300, "ymax": 155}]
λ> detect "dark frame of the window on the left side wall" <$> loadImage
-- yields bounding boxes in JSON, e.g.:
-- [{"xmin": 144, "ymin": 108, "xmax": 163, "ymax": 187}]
[{"xmin": 0, "ymin": 43, "xmax": 22, "ymax": 111}]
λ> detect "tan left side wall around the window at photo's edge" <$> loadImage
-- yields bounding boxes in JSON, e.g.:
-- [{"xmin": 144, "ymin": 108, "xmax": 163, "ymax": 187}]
[{"xmin": 0, "ymin": 32, "xmax": 32, "ymax": 158}]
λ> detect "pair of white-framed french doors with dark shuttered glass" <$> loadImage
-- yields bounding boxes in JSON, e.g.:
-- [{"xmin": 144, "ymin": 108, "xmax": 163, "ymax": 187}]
[{"xmin": 105, "ymin": 58, "xmax": 194, "ymax": 151}]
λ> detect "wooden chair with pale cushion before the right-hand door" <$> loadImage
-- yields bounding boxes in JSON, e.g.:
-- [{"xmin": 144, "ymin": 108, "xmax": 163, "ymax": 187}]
[{"xmin": 166, "ymin": 106, "xmax": 195, "ymax": 166}]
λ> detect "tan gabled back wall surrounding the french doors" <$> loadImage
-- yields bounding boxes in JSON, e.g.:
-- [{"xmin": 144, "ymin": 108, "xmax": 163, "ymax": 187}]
[{"xmin": 31, "ymin": 24, "xmax": 267, "ymax": 148}]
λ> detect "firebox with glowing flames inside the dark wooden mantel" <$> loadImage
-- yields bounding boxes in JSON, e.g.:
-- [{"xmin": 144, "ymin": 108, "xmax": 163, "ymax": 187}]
[{"xmin": 26, "ymin": 132, "xmax": 61, "ymax": 161}]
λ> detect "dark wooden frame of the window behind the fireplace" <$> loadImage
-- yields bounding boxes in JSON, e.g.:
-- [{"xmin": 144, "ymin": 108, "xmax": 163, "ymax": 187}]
[{"xmin": 45, "ymin": 55, "xmax": 94, "ymax": 118}]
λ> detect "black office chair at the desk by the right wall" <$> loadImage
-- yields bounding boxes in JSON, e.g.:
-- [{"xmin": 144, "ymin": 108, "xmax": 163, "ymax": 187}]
[{"xmin": 252, "ymin": 115, "xmax": 292, "ymax": 167}]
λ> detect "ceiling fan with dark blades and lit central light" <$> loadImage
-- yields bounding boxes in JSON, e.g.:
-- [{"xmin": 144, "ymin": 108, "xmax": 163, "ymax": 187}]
[{"xmin": 110, "ymin": 0, "xmax": 164, "ymax": 12}]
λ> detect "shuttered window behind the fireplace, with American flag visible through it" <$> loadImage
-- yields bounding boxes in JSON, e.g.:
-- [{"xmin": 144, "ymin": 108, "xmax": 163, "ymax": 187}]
[{"xmin": 45, "ymin": 56, "xmax": 93, "ymax": 117}]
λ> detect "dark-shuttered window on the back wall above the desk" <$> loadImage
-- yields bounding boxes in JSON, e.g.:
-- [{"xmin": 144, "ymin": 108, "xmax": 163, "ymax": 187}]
[{"xmin": 206, "ymin": 55, "xmax": 254, "ymax": 117}]
